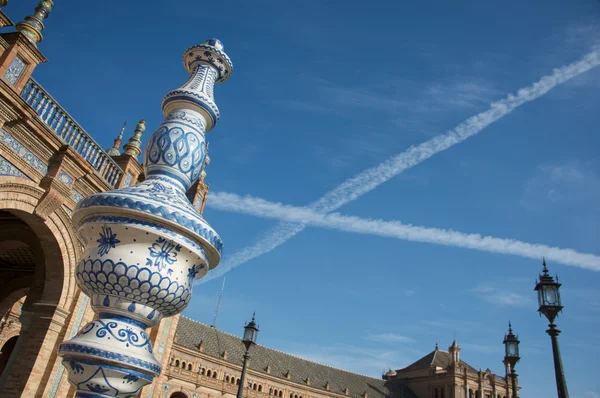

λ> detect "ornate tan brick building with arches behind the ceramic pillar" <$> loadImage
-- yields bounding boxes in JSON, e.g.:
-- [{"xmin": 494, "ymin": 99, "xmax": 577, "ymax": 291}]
[{"xmin": 0, "ymin": 0, "xmax": 510, "ymax": 398}]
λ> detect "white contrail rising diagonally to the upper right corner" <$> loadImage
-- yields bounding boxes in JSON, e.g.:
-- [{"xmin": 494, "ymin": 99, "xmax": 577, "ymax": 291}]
[{"xmin": 201, "ymin": 51, "xmax": 600, "ymax": 281}]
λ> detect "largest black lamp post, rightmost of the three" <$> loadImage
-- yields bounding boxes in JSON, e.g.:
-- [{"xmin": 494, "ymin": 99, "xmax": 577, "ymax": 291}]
[{"xmin": 534, "ymin": 259, "xmax": 569, "ymax": 398}]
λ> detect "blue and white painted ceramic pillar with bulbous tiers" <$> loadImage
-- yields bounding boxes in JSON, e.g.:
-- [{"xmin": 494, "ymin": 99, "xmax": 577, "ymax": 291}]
[{"xmin": 59, "ymin": 39, "xmax": 233, "ymax": 398}]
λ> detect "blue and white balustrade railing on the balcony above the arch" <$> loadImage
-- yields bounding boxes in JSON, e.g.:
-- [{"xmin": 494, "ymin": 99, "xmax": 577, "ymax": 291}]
[{"xmin": 21, "ymin": 79, "xmax": 123, "ymax": 187}]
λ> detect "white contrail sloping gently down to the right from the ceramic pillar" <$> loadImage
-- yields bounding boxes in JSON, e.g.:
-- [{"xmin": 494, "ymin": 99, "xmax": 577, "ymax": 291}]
[{"xmin": 208, "ymin": 192, "xmax": 600, "ymax": 271}]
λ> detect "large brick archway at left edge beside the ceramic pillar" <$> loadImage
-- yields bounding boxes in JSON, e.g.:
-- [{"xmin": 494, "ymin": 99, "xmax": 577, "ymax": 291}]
[{"xmin": 0, "ymin": 205, "xmax": 74, "ymax": 395}]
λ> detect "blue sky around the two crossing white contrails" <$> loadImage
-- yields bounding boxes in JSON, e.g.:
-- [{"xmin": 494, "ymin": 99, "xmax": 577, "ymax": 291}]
[{"xmin": 4, "ymin": 0, "xmax": 600, "ymax": 398}]
